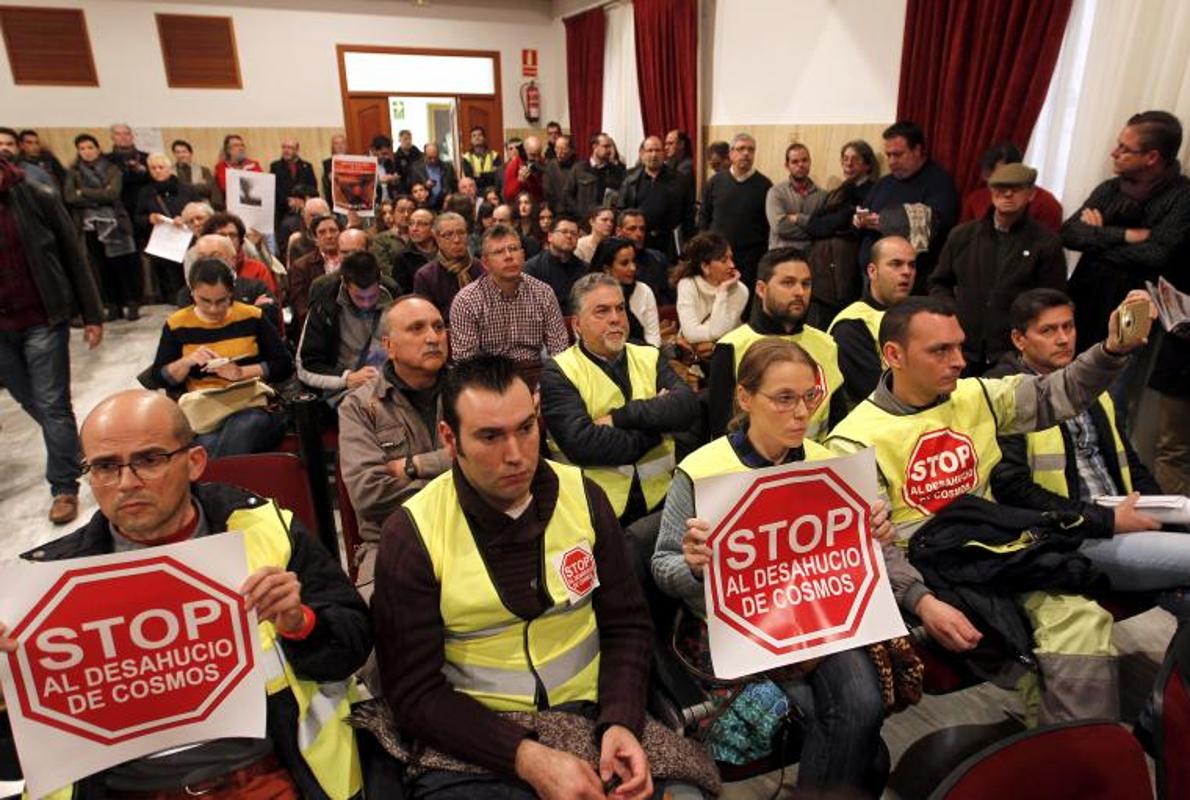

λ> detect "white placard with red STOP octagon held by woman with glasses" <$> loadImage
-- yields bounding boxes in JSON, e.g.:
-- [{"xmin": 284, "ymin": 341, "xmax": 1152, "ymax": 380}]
[{"xmin": 695, "ymin": 450, "xmax": 906, "ymax": 679}]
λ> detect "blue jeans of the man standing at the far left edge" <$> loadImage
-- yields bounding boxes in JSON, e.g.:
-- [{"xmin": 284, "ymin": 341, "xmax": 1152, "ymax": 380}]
[{"xmin": 0, "ymin": 323, "xmax": 82, "ymax": 496}]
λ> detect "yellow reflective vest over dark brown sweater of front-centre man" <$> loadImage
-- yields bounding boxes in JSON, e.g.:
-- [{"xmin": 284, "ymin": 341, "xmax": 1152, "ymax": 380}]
[{"xmin": 405, "ymin": 461, "xmax": 600, "ymax": 711}]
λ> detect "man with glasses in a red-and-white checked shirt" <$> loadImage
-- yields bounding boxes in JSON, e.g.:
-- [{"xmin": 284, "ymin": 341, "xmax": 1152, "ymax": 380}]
[{"xmin": 450, "ymin": 224, "xmax": 570, "ymax": 389}]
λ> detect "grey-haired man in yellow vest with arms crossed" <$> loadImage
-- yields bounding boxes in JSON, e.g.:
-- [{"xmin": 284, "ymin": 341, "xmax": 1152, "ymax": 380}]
[{"xmin": 541, "ymin": 273, "xmax": 701, "ymax": 525}]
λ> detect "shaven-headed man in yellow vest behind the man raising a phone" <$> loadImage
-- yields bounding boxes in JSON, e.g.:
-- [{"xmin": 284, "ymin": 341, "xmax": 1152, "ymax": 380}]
[{"xmin": 827, "ymin": 236, "xmax": 917, "ymax": 408}]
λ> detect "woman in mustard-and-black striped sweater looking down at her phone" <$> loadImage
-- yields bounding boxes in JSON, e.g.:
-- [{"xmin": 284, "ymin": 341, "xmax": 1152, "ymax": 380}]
[{"xmin": 145, "ymin": 258, "xmax": 294, "ymax": 458}]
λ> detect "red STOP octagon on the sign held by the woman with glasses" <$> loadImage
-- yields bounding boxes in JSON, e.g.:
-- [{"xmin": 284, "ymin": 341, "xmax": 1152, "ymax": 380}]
[{"xmin": 708, "ymin": 467, "xmax": 879, "ymax": 655}]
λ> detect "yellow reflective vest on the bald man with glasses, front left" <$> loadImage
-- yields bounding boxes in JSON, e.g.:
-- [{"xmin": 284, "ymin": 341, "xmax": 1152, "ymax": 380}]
[{"xmin": 235, "ymin": 504, "xmax": 363, "ymax": 800}]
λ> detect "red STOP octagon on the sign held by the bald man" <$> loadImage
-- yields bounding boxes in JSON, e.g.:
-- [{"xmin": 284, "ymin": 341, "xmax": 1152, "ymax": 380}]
[{"xmin": 10, "ymin": 556, "xmax": 255, "ymax": 744}]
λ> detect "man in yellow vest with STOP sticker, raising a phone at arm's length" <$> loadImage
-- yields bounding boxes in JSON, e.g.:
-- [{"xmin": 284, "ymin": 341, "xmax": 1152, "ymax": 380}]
[{"xmin": 828, "ymin": 292, "xmax": 1155, "ymax": 723}]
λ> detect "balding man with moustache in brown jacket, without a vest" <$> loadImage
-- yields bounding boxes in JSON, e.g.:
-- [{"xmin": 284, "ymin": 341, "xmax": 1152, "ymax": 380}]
[{"xmin": 339, "ymin": 295, "xmax": 450, "ymax": 598}]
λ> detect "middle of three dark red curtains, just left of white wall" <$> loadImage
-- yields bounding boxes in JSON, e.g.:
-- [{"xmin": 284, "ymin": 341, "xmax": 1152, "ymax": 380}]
[{"xmin": 632, "ymin": 0, "xmax": 699, "ymax": 156}]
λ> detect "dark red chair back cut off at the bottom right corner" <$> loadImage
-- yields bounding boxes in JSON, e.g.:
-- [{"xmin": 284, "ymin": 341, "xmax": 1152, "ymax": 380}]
[{"xmin": 1153, "ymin": 625, "xmax": 1190, "ymax": 800}]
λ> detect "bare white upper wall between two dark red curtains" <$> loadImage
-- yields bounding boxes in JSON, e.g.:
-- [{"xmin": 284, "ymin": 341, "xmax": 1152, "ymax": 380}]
[{"xmin": 702, "ymin": 0, "xmax": 907, "ymax": 125}]
